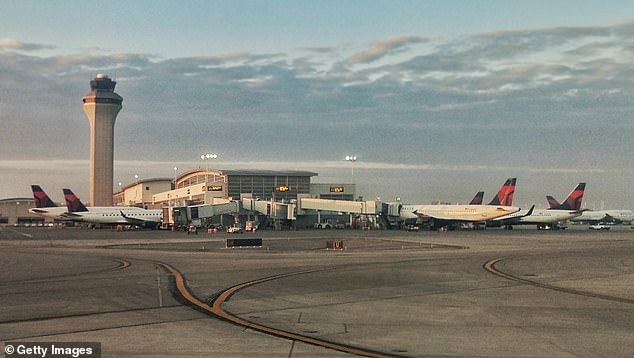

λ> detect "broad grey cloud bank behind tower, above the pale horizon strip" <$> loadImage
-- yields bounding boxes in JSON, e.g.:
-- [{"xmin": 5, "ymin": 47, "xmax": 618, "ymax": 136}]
[{"xmin": 0, "ymin": 24, "xmax": 634, "ymax": 204}]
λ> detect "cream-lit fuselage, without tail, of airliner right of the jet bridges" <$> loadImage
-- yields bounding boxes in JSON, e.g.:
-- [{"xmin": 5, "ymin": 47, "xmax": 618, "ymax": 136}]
[{"xmin": 400, "ymin": 205, "xmax": 520, "ymax": 222}]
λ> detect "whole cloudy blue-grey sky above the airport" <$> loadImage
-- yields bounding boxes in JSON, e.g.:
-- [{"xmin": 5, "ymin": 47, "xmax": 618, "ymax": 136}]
[{"xmin": 0, "ymin": 0, "xmax": 634, "ymax": 209}]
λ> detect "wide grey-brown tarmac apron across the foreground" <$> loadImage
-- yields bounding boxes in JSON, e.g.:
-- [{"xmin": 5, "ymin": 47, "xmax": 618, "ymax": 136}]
[{"xmin": 0, "ymin": 226, "xmax": 634, "ymax": 357}]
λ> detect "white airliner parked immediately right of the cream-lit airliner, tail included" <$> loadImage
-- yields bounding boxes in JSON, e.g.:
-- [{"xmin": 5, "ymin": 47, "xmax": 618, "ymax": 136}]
[{"xmin": 487, "ymin": 183, "xmax": 586, "ymax": 230}]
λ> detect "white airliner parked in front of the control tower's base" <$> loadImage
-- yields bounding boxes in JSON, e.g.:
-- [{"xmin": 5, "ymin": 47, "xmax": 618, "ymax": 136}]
[{"xmin": 64, "ymin": 189, "xmax": 163, "ymax": 229}]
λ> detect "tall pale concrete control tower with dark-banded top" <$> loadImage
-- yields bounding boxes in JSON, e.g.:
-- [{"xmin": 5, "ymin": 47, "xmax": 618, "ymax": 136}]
[{"xmin": 83, "ymin": 74, "xmax": 123, "ymax": 206}]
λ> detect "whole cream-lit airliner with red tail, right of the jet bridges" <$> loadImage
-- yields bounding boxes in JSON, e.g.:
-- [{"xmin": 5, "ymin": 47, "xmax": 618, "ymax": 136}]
[{"xmin": 400, "ymin": 178, "xmax": 520, "ymax": 227}]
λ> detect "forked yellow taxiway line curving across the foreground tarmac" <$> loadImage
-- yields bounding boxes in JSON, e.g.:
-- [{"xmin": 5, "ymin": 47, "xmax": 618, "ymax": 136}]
[{"xmin": 159, "ymin": 263, "xmax": 401, "ymax": 357}]
